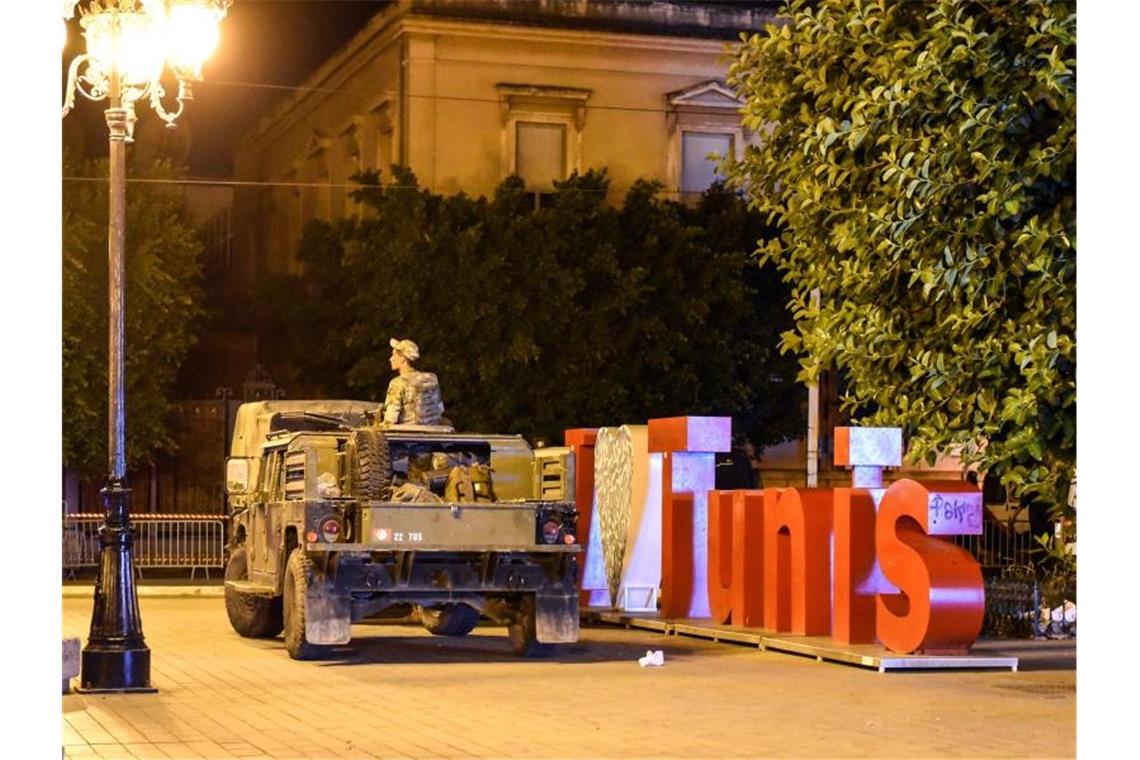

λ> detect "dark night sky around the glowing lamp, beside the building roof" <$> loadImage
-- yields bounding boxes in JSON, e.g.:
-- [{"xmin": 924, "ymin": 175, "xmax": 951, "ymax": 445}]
[{"xmin": 64, "ymin": 0, "xmax": 390, "ymax": 177}]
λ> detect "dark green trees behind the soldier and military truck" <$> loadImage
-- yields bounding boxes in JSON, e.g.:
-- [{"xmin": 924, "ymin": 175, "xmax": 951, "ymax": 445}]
[{"xmin": 261, "ymin": 166, "xmax": 803, "ymax": 443}]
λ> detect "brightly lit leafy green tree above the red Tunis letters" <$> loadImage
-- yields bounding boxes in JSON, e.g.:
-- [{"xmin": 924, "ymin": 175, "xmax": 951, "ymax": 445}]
[{"xmin": 730, "ymin": 0, "xmax": 1076, "ymax": 507}]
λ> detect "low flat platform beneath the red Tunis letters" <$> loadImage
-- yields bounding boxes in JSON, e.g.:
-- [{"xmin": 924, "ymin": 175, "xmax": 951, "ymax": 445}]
[{"xmin": 581, "ymin": 608, "xmax": 1018, "ymax": 673}]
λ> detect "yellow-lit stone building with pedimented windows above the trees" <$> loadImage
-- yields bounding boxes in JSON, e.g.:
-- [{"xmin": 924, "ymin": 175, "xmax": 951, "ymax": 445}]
[{"xmin": 234, "ymin": 0, "xmax": 777, "ymax": 279}]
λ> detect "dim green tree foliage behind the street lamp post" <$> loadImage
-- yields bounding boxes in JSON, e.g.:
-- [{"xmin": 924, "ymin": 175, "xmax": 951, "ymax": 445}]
[{"xmin": 63, "ymin": 158, "xmax": 202, "ymax": 476}]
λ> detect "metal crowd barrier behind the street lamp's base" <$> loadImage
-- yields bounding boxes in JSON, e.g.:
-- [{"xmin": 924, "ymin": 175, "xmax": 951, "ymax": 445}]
[{"xmin": 63, "ymin": 514, "xmax": 226, "ymax": 579}]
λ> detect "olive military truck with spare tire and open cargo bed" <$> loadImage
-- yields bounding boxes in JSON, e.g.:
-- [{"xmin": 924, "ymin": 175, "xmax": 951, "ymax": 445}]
[{"xmin": 225, "ymin": 401, "xmax": 581, "ymax": 660}]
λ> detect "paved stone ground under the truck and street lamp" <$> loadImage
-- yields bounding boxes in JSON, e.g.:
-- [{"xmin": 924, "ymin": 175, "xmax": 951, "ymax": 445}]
[{"xmin": 63, "ymin": 596, "xmax": 1076, "ymax": 760}]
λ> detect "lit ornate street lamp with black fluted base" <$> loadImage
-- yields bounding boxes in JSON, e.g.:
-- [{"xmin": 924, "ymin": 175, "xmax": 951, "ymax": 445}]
[{"xmin": 63, "ymin": 0, "xmax": 231, "ymax": 692}]
